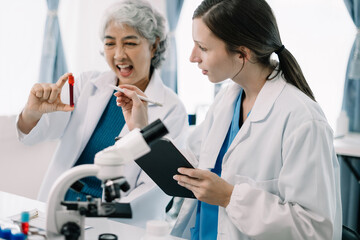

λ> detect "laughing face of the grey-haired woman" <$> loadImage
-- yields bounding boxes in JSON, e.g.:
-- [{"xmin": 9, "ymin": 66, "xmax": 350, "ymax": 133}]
[{"xmin": 104, "ymin": 22, "xmax": 155, "ymax": 91}]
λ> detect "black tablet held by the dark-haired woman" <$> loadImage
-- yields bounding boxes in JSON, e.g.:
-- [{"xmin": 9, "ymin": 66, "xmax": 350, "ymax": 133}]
[{"xmin": 135, "ymin": 138, "xmax": 195, "ymax": 198}]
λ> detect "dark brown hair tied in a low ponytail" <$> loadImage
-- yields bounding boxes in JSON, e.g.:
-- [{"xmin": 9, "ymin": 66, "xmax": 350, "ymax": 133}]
[{"xmin": 193, "ymin": 0, "xmax": 315, "ymax": 101}]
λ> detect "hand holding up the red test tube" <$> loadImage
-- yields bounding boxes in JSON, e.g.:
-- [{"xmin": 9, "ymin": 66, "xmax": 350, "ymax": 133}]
[{"xmin": 18, "ymin": 73, "xmax": 74, "ymax": 134}]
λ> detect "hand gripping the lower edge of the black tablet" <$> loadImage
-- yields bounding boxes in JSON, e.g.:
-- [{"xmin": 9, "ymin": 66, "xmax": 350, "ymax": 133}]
[{"xmin": 174, "ymin": 168, "xmax": 234, "ymax": 207}]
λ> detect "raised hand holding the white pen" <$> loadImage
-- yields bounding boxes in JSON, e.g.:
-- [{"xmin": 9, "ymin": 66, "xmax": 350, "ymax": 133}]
[{"xmin": 114, "ymin": 85, "xmax": 148, "ymax": 131}]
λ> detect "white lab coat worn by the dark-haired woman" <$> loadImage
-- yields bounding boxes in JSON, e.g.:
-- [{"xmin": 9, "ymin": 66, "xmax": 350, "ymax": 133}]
[{"xmin": 172, "ymin": 70, "xmax": 342, "ymax": 240}]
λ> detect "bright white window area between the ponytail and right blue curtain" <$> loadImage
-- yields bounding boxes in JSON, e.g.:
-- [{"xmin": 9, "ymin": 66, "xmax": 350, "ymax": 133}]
[{"xmin": 268, "ymin": 0, "xmax": 356, "ymax": 129}]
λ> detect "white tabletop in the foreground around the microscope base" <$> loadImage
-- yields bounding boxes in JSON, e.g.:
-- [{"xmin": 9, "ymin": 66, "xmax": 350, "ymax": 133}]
[{"xmin": 0, "ymin": 191, "xmax": 182, "ymax": 240}]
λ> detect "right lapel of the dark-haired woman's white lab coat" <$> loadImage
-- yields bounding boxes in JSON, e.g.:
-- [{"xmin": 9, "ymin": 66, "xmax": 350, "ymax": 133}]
[{"xmin": 223, "ymin": 73, "xmax": 286, "ymax": 159}]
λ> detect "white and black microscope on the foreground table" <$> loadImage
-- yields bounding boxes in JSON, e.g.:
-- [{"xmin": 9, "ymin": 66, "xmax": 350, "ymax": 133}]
[{"xmin": 46, "ymin": 119, "xmax": 168, "ymax": 240}]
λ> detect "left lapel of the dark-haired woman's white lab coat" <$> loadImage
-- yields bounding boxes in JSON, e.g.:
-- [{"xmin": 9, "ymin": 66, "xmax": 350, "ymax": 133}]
[{"xmin": 199, "ymin": 83, "xmax": 241, "ymax": 169}]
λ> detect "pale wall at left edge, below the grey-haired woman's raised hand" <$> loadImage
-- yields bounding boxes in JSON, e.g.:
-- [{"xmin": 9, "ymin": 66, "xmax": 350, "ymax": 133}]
[{"xmin": 0, "ymin": 116, "xmax": 57, "ymax": 199}]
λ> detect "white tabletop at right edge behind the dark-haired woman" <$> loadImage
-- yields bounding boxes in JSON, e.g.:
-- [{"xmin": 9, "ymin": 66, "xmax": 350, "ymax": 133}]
[{"xmin": 334, "ymin": 133, "xmax": 360, "ymax": 158}]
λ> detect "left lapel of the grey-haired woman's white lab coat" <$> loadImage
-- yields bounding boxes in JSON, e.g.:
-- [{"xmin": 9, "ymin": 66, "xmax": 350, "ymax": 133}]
[{"xmin": 76, "ymin": 72, "xmax": 116, "ymax": 159}]
